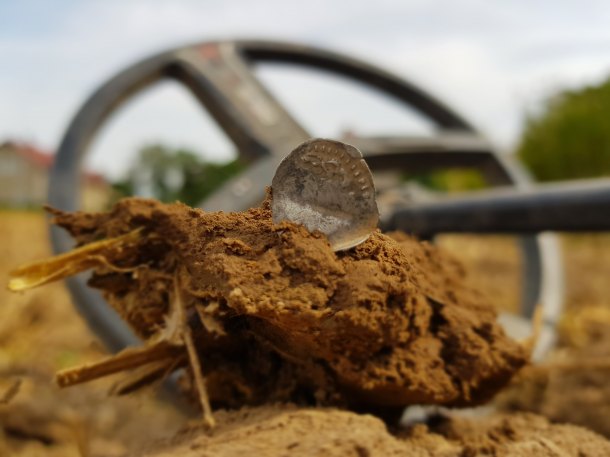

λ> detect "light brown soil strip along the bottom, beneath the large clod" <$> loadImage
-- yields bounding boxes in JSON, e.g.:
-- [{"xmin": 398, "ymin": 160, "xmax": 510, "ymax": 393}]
[{"xmin": 139, "ymin": 405, "xmax": 610, "ymax": 457}]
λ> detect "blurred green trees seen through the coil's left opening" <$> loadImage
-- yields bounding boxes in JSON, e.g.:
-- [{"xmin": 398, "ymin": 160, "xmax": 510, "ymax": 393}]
[{"xmin": 114, "ymin": 144, "xmax": 243, "ymax": 206}]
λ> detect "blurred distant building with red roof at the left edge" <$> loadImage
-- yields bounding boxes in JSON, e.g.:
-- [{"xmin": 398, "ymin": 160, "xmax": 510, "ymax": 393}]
[{"xmin": 0, "ymin": 141, "xmax": 111, "ymax": 211}]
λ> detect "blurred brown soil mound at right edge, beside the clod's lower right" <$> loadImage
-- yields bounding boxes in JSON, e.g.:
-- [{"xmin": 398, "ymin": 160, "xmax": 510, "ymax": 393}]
[{"xmin": 498, "ymin": 305, "xmax": 610, "ymax": 437}]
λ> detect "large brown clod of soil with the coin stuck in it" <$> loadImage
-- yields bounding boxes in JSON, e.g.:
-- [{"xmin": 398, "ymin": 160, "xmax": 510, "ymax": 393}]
[{"xmin": 34, "ymin": 194, "xmax": 528, "ymax": 411}]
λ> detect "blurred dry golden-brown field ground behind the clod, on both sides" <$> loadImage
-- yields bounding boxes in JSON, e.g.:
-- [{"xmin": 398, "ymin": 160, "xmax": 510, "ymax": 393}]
[{"xmin": 0, "ymin": 211, "xmax": 610, "ymax": 457}]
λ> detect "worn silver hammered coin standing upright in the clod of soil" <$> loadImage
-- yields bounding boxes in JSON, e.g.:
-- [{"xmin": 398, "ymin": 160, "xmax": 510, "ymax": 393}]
[{"xmin": 271, "ymin": 138, "xmax": 379, "ymax": 251}]
